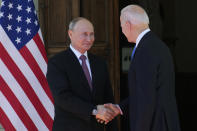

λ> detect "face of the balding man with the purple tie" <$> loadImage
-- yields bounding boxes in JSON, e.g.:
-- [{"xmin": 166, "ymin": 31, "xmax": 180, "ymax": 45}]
[{"xmin": 68, "ymin": 20, "xmax": 94, "ymax": 54}]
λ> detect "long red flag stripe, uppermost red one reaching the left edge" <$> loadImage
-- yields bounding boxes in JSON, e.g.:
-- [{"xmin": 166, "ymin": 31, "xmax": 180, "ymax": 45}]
[{"xmin": 0, "ymin": 42, "xmax": 53, "ymax": 128}]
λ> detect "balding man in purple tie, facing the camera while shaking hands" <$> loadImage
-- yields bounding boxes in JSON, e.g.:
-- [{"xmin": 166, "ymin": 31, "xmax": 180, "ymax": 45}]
[{"xmin": 47, "ymin": 17, "xmax": 117, "ymax": 131}]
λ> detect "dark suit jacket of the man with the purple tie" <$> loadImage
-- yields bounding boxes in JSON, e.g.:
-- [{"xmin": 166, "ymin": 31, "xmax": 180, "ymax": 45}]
[{"xmin": 47, "ymin": 48, "xmax": 117, "ymax": 131}]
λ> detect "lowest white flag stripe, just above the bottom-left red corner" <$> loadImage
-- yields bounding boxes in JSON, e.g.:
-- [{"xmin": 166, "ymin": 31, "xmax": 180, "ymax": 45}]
[{"xmin": 0, "ymin": 91, "xmax": 27, "ymax": 131}]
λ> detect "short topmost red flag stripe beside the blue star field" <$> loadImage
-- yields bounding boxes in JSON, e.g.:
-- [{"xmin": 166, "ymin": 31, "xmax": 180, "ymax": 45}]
[{"xmin": 33, "ymin": 33, "xmax": 48, "ymax": 63}]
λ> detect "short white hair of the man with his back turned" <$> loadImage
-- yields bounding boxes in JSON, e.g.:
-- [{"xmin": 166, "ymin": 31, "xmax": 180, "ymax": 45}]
[{"xmin": 121, "ymin": 5, "xmax": 149, "ymax": 25}]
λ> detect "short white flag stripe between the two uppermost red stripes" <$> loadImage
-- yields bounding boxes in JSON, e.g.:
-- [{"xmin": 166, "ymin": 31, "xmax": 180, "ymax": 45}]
[{"xmin": 26, "ymin": 39, "xmax": 47, "ymax": 76}]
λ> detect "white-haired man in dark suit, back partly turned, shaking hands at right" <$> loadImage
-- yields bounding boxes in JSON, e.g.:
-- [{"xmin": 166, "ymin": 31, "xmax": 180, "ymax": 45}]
[{"xmin": 105, "ymin": 5, "xmax": 180, "ymax": 131}]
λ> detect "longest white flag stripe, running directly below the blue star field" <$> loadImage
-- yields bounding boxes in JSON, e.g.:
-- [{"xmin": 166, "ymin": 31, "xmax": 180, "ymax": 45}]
[{"xmin": 0, "ymin": 25, "xmax": 54, "ymax": 119}]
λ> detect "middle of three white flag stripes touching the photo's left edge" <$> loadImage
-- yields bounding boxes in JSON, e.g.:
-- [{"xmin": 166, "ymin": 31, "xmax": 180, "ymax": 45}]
[{"xmin": 0, "ymin": 59, "xmax": 47, "ymax": 129}]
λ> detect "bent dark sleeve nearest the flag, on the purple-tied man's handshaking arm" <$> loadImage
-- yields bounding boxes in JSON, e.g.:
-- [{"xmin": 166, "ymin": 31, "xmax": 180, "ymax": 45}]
[{"xmin": 47, "ymin": 60, "xmax": 94, "ymax": 120}]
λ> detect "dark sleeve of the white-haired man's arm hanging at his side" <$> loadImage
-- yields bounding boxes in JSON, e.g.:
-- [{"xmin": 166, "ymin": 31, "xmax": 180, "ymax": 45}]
[{"xmin": 133, "ymin": 50, "xmax": 158, "ymax": 131}]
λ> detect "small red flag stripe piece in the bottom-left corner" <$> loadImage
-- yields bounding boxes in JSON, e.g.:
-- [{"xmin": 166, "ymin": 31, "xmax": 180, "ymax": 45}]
[{"xmin": 0, "ymin": 107, "xmax": 16, "ymax": 131}]
